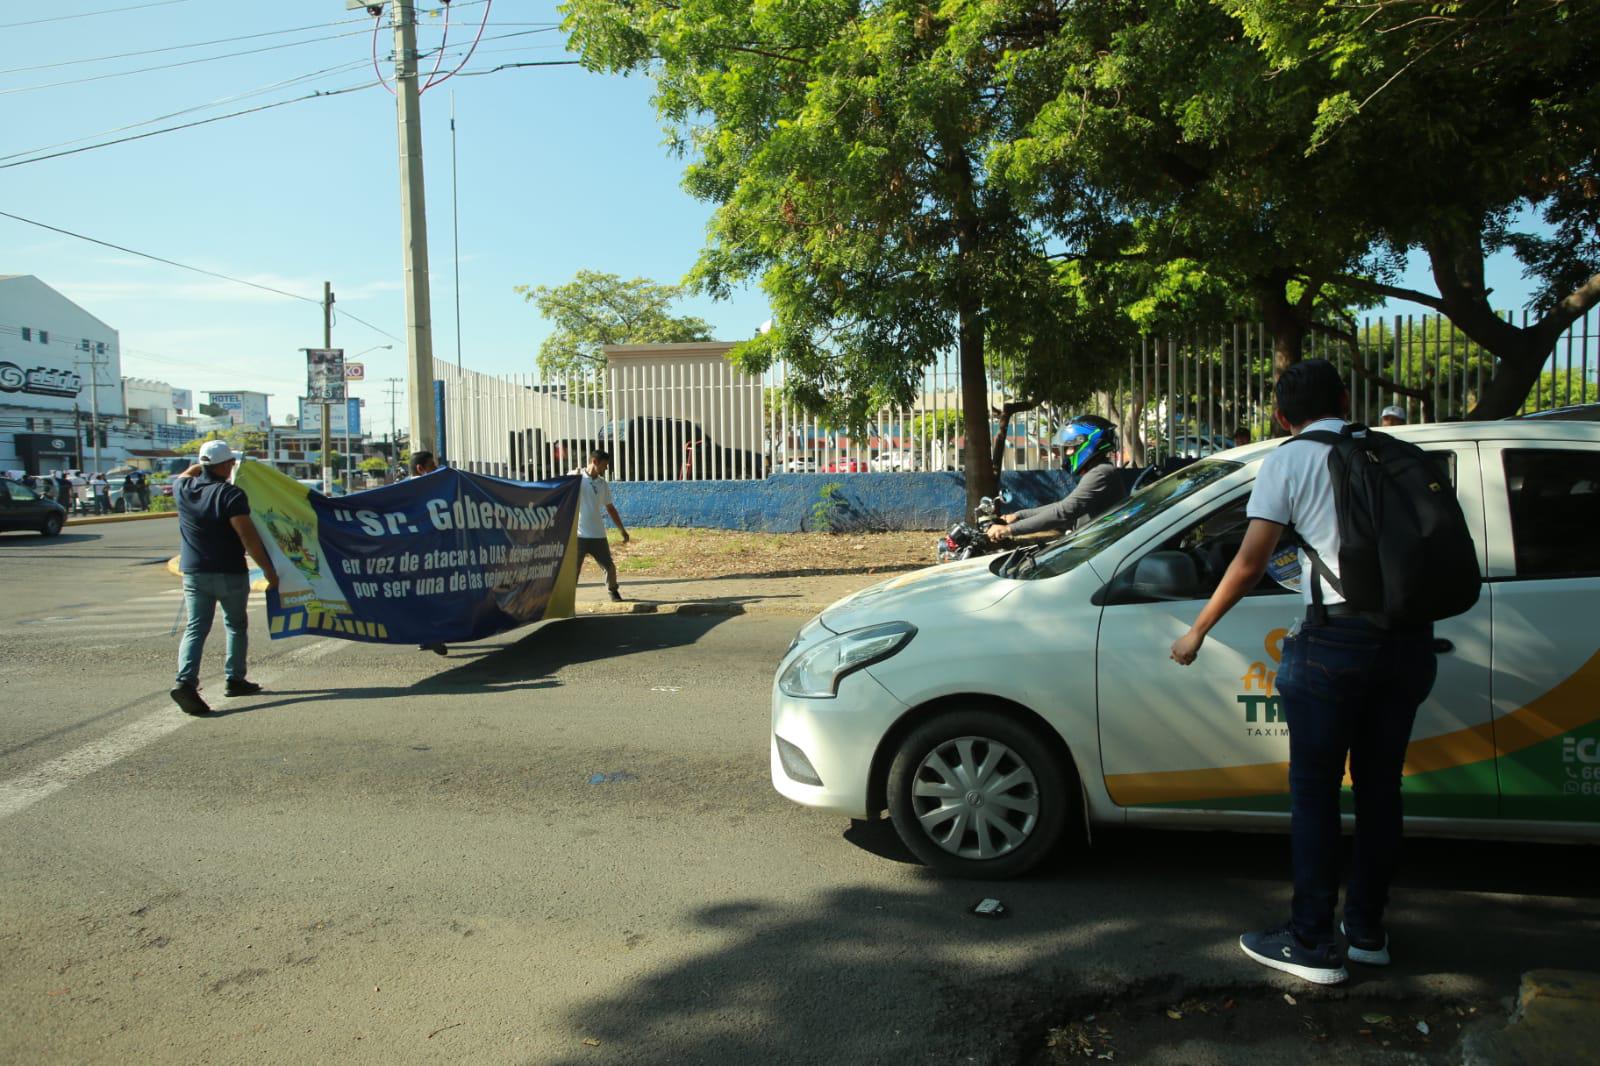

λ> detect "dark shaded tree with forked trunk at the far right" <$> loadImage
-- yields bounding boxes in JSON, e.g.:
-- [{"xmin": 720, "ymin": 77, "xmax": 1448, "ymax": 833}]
[{"xmin": 1226, "ymin": 0, "xmax": 1600, "ymax": 418}]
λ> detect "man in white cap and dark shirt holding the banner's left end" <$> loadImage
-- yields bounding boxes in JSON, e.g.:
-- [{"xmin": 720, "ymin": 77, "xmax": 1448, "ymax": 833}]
[{"xmin": 171, "ymin": 440, "xmax": 278, "ymax": 715}]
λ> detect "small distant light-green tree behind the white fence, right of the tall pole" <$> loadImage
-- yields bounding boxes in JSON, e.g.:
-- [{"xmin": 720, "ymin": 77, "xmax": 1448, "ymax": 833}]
[{"xmin": 515, "ymin": 271, "xmax": 710, "ymax": 379}]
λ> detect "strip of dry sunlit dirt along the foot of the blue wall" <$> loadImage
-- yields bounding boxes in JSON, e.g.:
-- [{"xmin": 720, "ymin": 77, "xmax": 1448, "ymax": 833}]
[{"xmin": 611, "ymin": 530, "xmax": 939, "ymax": 578}]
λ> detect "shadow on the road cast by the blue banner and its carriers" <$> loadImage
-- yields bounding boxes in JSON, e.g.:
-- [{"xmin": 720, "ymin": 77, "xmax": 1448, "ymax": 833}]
[{"xmin": 206, "ymin": 613, "xmax": 731, "ymax": 717}]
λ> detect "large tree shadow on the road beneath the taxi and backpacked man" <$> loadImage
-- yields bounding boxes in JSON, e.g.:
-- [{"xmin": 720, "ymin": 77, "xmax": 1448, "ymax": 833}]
[{"xmin": 544, "ymin": 823, "xmax": 1597, "ymax": 1064}]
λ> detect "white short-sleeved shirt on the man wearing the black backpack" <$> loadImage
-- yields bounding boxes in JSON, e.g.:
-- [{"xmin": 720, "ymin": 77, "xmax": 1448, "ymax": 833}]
[{"xmin": 1245, "ymin": 418, "xmax": 1344, "ymax": 605}]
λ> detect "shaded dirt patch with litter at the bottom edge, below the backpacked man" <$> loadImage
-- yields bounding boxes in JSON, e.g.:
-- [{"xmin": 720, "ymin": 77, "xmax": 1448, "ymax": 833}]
[{"xmin": 1021, "ymin": 988, "xmax": 1493, "ymax": 1066}]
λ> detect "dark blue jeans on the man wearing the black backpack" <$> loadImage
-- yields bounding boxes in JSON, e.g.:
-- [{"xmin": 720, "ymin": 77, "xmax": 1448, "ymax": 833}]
[{"xmin": 1277, "ymin": 618, "xmax": 1437, "ymax": 944}]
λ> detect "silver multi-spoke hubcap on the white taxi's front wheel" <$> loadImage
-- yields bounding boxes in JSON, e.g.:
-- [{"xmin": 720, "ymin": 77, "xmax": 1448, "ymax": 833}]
[{"xmin": 910, "ymin": 736, "xmax": 1038, "ymax": 860}]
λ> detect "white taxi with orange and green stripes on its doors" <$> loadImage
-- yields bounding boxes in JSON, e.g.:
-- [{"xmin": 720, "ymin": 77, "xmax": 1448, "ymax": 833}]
[{"xmin": 771, "ymin": 421, "xmax": 1600, "ymax": 877}]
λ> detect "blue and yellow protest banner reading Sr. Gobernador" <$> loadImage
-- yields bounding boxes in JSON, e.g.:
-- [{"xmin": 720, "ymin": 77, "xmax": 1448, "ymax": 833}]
[{"xmin": 234, "ymin": 463, "xmax": 581, "ymax": 643}]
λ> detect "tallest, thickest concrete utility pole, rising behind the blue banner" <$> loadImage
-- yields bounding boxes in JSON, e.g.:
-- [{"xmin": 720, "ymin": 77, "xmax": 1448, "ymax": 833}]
[{"xmin": 390, "ymin": 0, "xmax": 435, "ymax": 451}]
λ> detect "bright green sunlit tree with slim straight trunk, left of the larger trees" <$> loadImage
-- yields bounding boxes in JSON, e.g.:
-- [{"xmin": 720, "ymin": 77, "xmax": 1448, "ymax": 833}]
[{"xmin": 565, "ymin": 0, "xmax": 1126, "ymax": 503}]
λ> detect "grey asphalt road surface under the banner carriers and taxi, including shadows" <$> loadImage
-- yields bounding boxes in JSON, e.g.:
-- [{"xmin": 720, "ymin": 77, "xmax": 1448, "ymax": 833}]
[{"xmin": 0, "ymin": 522, "xmax": 1600, "ymax": 1063}]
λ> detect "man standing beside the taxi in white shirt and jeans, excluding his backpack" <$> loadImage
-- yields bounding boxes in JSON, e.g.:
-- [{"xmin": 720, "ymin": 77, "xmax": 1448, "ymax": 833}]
[{"xmin": 1171, "ymin": 359, "xmax": 1437, "ymax": 984}]
